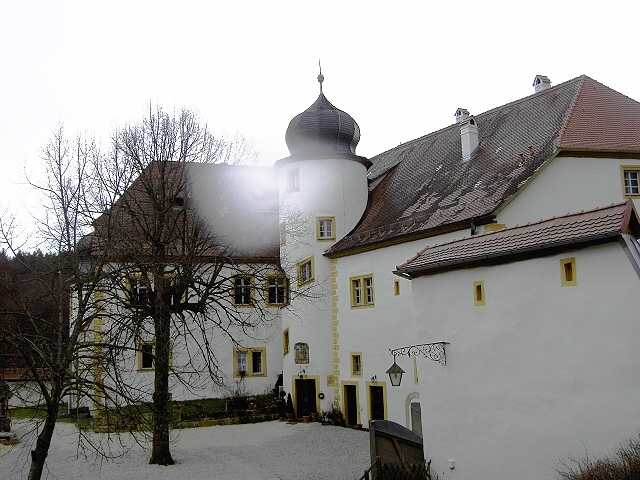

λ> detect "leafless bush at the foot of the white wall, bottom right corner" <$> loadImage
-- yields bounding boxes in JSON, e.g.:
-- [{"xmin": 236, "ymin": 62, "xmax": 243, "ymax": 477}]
[{"xmin": 558, "ymin": 435, "xmax": 640, "ymax": 480}]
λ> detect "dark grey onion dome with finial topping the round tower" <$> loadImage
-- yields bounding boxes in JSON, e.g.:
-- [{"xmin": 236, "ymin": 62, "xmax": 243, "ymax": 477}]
[{"xmin": 285, "ymin": 66, "xmax": 370, "ymax": 167}]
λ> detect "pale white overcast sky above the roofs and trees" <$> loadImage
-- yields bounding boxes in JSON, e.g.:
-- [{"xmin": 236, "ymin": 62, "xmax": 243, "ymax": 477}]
[{"xmin": 0, "ymin": 0, "xmax": 640, "ymax": 227}]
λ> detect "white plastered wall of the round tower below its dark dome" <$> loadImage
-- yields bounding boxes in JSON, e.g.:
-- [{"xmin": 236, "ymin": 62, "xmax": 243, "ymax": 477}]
[{"xmin": 277, "ymin": 159, "xmax": 368, "ymax": 410}]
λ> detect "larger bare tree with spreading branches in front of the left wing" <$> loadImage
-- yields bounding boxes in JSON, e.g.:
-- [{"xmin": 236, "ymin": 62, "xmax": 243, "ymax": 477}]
[{"xmin": 94, "ymin": 109, "xmax": 296, "ymax": 465}]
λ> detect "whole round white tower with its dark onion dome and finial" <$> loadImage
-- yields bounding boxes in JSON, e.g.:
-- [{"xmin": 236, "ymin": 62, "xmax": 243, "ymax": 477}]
[{"xmin": 276, "ymin": 65, "xmax": 371, "ymax": 416}]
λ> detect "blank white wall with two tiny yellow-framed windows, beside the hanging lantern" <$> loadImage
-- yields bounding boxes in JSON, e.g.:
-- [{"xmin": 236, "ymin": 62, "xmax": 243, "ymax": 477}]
[{"xmin": 410, "ymin": 242, "xmax": 640, "ymax": 480}]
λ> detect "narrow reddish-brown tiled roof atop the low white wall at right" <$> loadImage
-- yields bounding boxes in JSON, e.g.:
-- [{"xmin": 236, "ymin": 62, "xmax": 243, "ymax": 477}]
[{"xmin": 397, "ymin": 200, "xmax": 640, "ymax": 277}]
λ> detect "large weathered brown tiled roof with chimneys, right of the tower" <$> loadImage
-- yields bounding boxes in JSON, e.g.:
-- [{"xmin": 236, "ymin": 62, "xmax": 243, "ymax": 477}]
[{"xmin": 326, "ymin": 75, "xmax": 640, "ymax": 257}]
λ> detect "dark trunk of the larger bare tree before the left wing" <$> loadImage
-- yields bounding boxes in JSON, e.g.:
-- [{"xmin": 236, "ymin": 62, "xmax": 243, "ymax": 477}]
[{"xmin": 149, "ymin": 295, "xmax": 174, "ymax": 465}]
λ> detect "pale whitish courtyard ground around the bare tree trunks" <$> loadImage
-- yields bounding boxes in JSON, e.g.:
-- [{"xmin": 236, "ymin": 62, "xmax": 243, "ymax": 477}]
[{"xmin": 0, "ymin": 422, "xmax": 369, "ymax": 480}]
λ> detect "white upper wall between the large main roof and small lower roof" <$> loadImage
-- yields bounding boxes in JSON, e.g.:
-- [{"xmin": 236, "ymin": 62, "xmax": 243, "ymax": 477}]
[{"xmin": 496, "ymin": 157, "xmax": 640, "ymax": 228}]
